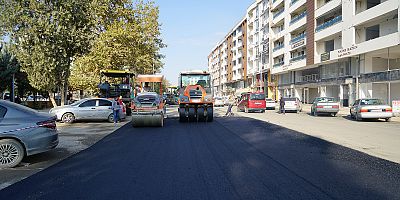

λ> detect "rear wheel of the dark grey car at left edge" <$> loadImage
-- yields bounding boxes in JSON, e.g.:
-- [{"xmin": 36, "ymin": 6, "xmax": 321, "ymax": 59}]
[{"xmin": 0, "ymin": 139, "xmax": 25, "ymax": 169}]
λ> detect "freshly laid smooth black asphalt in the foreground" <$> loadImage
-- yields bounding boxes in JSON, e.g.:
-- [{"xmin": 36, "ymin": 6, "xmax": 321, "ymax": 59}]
[{"xmin": 0, "ymin": 117, "xmax": 400, "ymax": 200}]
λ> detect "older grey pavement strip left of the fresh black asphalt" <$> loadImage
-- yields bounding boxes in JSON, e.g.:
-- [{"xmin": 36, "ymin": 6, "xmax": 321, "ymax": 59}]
[{"xmin": 0, "ymin": 120, "xmax": 129, "ymax": 190}]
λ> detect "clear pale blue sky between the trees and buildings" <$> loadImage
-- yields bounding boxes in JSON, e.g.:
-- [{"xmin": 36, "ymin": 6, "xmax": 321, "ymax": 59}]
[{"xmin": 155, "ymin": 0, "xmax": 254, "ymax": 85}]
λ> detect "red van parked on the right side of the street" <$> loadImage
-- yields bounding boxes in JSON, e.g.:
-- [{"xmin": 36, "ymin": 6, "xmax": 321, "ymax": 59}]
[{"xmin": 237, "ymin": 92, "xmax": 265, "ymax": 113}]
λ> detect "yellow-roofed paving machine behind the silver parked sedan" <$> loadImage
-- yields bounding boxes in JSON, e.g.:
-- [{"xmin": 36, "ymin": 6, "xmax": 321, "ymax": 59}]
[{"xmin": 98, "ymin": 70, "xmax": 135, "ymax": 115}]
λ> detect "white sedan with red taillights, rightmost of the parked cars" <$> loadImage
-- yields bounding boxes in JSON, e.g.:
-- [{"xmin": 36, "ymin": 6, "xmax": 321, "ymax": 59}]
[{"xmin": 350, "ymin": 99, "xmax": 393, "ymax": 121}]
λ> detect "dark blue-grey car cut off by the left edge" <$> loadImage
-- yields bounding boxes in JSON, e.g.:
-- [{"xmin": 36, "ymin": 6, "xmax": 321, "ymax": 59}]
[{"xmin": 0, "ymin": 100, "xmax": 58, "ymax": 168}]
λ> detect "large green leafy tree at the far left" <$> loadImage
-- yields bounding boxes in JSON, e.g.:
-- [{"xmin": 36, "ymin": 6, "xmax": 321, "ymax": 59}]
[{"xmin": 0, "ymin": 0, "xmax": 99, "ymax": 106}]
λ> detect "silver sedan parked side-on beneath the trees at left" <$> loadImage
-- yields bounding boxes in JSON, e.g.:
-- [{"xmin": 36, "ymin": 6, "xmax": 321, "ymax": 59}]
[{"xmin": 49, "ymin": 98, "xmax": 126, "ymax": 123}]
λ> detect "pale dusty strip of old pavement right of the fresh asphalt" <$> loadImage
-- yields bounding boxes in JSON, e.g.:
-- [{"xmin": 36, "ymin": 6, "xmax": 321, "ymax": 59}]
[{"xmin": 217, "ymin": 105, "xmax": 400, "ymax": 163}]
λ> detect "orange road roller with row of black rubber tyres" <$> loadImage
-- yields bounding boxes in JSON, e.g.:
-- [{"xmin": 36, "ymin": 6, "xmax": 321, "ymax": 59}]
[{"xmin": 178, "ymin": 71, "xmax": 214, "ymax": 122}]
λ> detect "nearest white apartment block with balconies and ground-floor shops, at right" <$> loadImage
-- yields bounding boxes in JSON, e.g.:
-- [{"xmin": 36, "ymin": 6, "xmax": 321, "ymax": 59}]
[{"xmin": 208, "ymin": 0, "xmax": 400, "ymax": 106}]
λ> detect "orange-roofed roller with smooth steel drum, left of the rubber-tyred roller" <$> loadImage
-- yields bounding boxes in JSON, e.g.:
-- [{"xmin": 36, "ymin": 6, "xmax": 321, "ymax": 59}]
[{"xmin": 131, "ymin": 75, "xmax": 166, "ymax": 127}]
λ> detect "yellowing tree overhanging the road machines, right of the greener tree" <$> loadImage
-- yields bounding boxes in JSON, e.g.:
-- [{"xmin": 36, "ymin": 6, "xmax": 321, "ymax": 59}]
[{"xmin": 69, "ymin": 0, "xmax": 165, "ymax": 91}]
